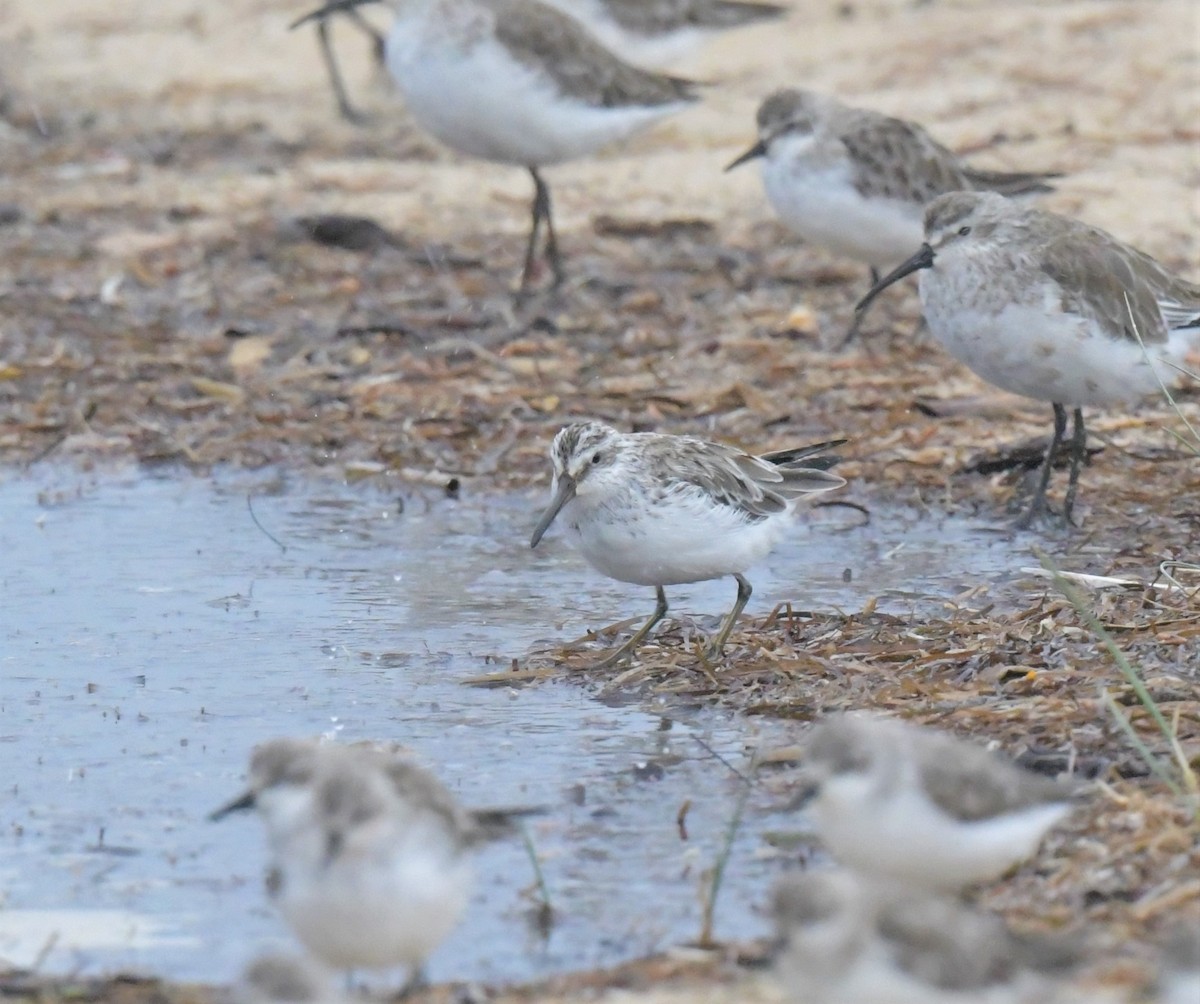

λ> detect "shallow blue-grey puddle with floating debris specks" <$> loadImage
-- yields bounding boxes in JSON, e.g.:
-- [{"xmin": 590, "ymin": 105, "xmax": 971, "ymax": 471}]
[{"xmin": 0, "ymin": 471, "xmax": 1027, "ymax": 980}]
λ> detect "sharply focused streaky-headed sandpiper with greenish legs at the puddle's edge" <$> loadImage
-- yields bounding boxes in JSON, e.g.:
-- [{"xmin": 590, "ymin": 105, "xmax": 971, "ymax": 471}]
[{"xmin": 529, "ymin": 422, "xmax": 846, "ymax": 668}]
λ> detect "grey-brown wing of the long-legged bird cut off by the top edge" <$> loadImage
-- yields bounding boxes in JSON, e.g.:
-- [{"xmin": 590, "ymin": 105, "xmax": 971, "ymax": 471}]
[{"xmin": 491, "ymin": 0, "xmax": 696, "ymax": 108}]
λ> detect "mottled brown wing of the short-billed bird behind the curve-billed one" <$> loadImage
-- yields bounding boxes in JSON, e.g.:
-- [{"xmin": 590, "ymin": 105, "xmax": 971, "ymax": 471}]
[{"xmin": 839, "ymin": 109, "xmax": 971, "ymax": 205}]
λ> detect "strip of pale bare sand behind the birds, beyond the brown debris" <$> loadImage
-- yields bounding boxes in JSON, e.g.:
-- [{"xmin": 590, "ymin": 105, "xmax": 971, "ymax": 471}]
[{"xmin": 7, "ymin": 0, "xmax": 1200, "ymax": 244}]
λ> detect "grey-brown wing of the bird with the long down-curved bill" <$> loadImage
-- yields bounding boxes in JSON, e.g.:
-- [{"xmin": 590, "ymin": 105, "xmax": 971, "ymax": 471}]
[{"xmin": 1038, "ymin": 220, "xmax": 1200, "ymax": 345}]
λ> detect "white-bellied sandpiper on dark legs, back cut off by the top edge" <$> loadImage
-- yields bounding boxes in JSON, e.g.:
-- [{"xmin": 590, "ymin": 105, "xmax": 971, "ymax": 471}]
[{"xmin": 294, "ymin": 0, "xmax": 696, "ymax": 290}]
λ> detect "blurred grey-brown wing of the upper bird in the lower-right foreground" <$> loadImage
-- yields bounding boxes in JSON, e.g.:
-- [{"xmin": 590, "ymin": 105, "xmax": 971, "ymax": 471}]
[{"xmin": 920, "ymin": 735, "xmax": 1070, "ymax": 822}]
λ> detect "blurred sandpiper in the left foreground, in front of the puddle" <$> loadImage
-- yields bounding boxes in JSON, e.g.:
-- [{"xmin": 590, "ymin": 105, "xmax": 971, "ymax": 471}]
[{"xmin": 211, "ymin": 739, "xmax": 523, "ymax": 984}]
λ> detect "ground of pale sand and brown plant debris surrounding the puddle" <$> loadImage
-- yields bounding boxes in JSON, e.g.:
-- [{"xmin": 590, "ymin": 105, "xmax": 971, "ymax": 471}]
[{"xmin": 0, "ymin": 0, "xmax": 1200, "ymax": 1004}]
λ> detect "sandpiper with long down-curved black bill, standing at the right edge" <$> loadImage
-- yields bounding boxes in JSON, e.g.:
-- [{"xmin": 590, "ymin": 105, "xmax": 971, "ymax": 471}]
[{"xmin": 857, "ymin": 192, "xmax": 1200, "ymax": 528}]
